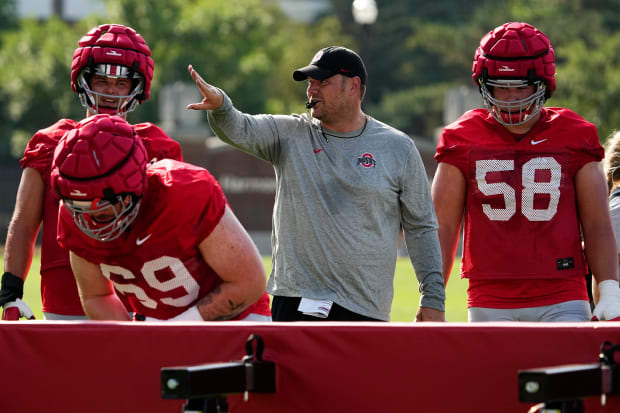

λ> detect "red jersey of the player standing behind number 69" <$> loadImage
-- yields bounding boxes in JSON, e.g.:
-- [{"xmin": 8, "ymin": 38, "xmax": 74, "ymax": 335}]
[{"xmin": 20, "ymin": 119, "xmax": 183, "ymax": 315}]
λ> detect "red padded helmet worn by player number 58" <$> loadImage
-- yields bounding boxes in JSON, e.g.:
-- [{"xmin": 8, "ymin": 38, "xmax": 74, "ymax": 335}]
[{"xmin": 472, "ymin": 22, "xmax": 555, "ymax": 125}]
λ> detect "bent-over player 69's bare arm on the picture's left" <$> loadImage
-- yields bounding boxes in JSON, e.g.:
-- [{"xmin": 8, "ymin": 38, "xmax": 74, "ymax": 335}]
[{"xmin": 69, "ymin": 252, "xmax": 130, "ymax": 321}]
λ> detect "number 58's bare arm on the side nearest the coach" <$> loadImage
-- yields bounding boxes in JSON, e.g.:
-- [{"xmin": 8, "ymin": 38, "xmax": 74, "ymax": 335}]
[{"xmin": 431, "ymin": 162, "xmax": 466, "ymax": 285}]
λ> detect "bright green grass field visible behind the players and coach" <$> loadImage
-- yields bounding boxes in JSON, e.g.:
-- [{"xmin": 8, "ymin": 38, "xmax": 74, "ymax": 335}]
[{"xmin": 12, "ymin": 251, "xmax": 467, "ymax": 321}]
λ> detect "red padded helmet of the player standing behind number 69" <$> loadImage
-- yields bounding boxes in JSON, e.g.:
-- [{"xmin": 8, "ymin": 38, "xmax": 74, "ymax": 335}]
[{"xmin": 71, "ymin": 24, "xmax": 153, "ymax": 116}]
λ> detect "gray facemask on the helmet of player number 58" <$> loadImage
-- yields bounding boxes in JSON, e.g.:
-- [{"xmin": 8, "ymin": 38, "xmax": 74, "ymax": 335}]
[{"xmin": 479, "ymin": 78, "xmax": 546, "ymax": 126}]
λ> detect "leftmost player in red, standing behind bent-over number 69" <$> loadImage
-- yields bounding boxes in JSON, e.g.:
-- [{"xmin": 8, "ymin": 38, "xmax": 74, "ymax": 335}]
[{"xmin": 0, "ymin": 24, "xmax": 182, "ymax": 320}]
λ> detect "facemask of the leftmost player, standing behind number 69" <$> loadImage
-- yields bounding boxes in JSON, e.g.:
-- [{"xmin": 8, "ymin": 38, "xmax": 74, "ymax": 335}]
[{"xmin": 77, "ymin": 63, "xmax": 144, "ymax": 116}]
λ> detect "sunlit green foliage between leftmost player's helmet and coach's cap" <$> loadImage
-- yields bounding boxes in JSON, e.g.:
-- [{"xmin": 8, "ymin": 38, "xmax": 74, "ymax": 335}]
[{"xmin": 108, "ymin": 0, "xmax": 336, "ymax": 119}]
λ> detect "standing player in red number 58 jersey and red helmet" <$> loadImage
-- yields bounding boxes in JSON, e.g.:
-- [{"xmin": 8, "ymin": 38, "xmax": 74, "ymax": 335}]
[{"xmin": 432, "ymin": 22, "xmax": 620, "ymax": 321}]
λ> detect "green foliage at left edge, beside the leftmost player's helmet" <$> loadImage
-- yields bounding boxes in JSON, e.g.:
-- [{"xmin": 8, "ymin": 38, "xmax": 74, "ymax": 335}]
[{"xmin": 0, "ymin": 18, "xmax": 85, "ymax": 157}]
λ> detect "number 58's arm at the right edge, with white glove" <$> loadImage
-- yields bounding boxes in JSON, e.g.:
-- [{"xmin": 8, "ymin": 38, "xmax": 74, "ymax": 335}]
[{"xmin": 575, "ymin": 162, "xmax": 620, "ymax": 320}]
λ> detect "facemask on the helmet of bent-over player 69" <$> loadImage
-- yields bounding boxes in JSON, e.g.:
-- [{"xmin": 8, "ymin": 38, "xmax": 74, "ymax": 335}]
[{"xmin": 62, "ymin": 194, "xmax": 141, "ymax": 242}]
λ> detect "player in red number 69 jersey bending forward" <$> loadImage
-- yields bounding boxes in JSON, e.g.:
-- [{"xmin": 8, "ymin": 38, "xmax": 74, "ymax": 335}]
[{"xmin": 51, "ymin": 115, "xmax": 270, "ymax": 321}]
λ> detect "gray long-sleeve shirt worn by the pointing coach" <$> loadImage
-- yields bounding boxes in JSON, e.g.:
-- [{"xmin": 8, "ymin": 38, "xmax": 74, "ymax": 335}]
[{"xmin": 208, "ymin": 96, "xmax": 445, "ymax": 320}]
